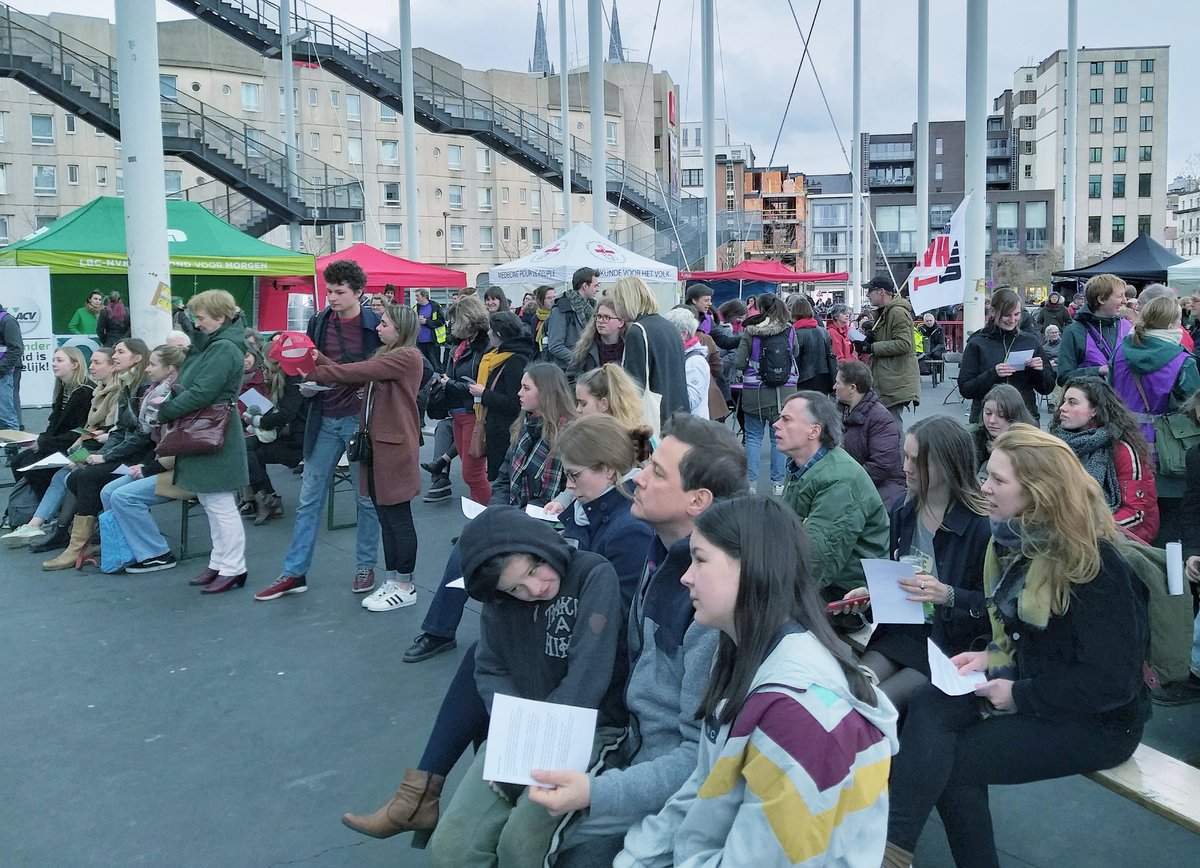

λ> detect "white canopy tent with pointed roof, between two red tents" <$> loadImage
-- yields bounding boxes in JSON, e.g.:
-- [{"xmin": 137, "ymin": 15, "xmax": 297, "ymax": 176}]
[{"xmin": 487, "ymin": 223, "xmax": 679, "ymax": 311}]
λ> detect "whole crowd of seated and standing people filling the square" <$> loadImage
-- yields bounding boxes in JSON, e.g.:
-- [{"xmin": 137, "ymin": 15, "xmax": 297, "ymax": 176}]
[{"xmin": 4, "ymin": 266, "xmax": 1200, "ymax": 868}]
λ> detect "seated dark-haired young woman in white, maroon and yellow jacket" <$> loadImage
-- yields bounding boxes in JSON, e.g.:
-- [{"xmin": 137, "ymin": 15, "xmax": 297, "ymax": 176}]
[{"xmin": 613, "ymin": 497, "xmax": 896, "ymax": 868}]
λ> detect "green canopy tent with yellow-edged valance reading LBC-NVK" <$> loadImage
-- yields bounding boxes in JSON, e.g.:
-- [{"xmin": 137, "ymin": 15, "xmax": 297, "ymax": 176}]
[{"xmin": 0, "ymin": 196, "xmax": 316, "ymax": 335}]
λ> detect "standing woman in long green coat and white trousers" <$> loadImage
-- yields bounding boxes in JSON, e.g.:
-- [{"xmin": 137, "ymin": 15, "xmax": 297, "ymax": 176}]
[{"xmin": 158, "ymin": 289, "xmax": 250, "ymax": 594}]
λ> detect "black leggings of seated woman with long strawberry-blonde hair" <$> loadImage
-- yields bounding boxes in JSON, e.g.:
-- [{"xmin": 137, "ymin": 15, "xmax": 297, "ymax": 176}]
[{"xmin": 888, "ymin": 684, "xmax": 1142, "ymax": 868}]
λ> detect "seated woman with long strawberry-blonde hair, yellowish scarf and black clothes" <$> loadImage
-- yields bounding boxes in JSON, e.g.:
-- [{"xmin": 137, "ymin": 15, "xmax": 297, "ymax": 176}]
[{"xmin": 883, "ymin": 425, "xmax": 1150, "ymax": 866}]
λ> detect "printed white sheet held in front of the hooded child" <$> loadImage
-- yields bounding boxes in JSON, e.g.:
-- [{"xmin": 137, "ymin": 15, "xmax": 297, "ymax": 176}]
[{"xmin": 484, "ymin": 693, "xmax": 596, "ymax": 786}]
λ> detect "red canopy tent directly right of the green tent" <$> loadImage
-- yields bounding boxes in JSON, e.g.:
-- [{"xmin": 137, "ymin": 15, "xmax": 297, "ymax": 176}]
[{"xmin": 258, "ymin": 243, "xmax": 467, "ymax": 331}]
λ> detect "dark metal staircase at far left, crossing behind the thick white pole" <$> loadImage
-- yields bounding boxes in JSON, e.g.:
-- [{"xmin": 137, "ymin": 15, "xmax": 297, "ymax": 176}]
[{"xmin": 0, "ymin": 4, "xmax": 362, "ymax": 237}]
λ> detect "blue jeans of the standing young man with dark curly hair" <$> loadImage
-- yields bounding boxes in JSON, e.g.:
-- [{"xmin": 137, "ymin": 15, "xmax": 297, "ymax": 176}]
[{"xmin": 283, "ymin": 415, "xmax": 379, "ymax": 576}]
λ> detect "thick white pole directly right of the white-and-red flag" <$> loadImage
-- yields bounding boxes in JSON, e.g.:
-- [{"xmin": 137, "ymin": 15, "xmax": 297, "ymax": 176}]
[{"xmin": 962, "ymin": 0, "xmax": 988, "ymax": 335}]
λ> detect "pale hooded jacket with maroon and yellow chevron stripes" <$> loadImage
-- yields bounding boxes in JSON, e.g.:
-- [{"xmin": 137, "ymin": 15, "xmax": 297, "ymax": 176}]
[{"xmin": 613, "ymin": 633, "xmax": 899, "ymax": 868}]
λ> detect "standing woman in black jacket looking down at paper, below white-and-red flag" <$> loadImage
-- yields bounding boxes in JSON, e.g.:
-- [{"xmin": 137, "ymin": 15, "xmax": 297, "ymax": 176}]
[{"xmin": 959, "ymin": 289, "xmax": 1055, "ymax": 424}]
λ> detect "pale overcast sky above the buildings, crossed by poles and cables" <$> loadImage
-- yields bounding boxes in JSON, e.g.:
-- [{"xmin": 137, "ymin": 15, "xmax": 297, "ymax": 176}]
[{"xmin": 16, "ymin": 0, "xmax": 1200, "ymax": 178}]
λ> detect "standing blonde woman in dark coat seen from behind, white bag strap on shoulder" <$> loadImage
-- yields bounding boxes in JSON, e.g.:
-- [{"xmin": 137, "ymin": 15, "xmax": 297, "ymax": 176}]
[{"xmin": 610, "ymin": 277, "xmax": 688, "ymax": 424}]
